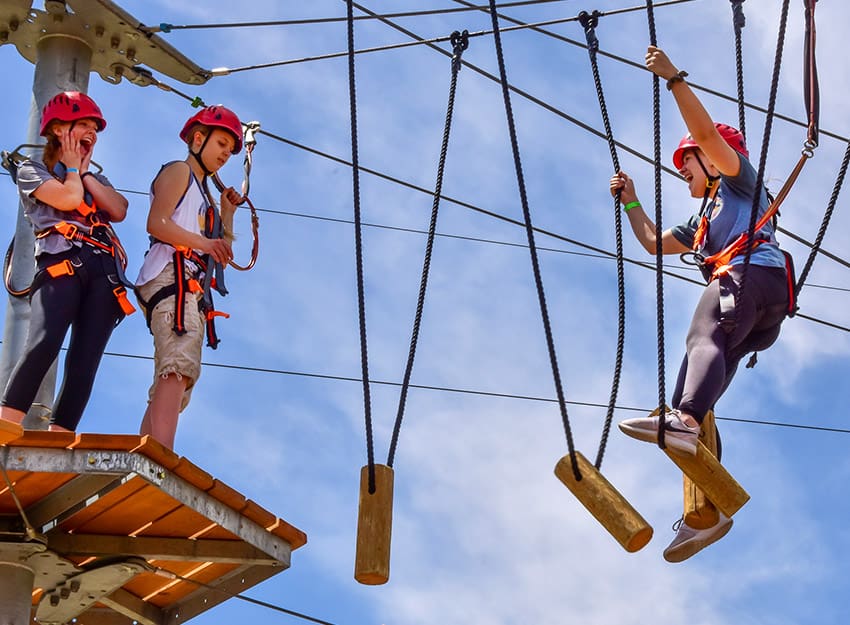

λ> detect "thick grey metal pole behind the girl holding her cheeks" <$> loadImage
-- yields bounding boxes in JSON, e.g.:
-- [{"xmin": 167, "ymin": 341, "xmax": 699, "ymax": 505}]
[{"xmin": 0, "ymin": 24, "xmax": 92, "ymax": 430}]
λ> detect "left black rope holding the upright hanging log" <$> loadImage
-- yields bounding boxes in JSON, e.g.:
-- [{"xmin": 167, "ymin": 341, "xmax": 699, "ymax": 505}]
[{"xmin": 346, "ymin": 0, "xmax": 375, "ymax": 494}]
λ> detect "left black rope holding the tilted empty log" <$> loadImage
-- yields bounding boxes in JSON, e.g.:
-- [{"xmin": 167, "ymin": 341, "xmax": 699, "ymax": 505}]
[{"xmin": 490, "ymin": 0, "xmax": 581, "ymax": 481}]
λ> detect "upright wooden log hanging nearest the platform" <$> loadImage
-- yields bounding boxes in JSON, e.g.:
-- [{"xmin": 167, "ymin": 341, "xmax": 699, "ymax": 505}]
[{"xmin": 354, "ymin": 464, "xmax": 393, "ymax": 586}]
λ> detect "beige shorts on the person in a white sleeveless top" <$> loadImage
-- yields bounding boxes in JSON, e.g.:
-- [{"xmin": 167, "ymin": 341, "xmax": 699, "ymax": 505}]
[{"xmin": 139, "ymin": 264, "xmax": 205, "ymax": 412}]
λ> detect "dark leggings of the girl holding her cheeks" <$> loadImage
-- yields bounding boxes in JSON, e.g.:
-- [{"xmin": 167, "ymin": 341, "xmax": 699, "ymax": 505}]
[{"xmin": 2, "ymin": 246, "xmax": 124, "ymax": 430}]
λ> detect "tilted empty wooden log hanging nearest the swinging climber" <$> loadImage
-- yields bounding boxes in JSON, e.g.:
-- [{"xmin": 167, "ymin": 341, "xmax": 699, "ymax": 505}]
[{"xmin": 555, "ymin": 452, "xmax": 652, "ymax": 553}]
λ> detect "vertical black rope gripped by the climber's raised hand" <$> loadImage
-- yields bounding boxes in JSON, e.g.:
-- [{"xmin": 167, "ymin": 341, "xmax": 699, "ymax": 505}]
[{"xmin": 646, "ymin": 0, "xmax": 667, "ymax": 449}]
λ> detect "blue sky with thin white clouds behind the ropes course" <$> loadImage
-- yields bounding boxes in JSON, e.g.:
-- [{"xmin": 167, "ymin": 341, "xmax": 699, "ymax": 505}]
[{"xmin": 0, "ymin": 0, "xmax": 850, "ymax": 625}]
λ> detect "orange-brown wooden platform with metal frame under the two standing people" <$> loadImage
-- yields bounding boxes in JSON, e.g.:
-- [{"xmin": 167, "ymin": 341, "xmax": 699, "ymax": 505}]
[{"xmin": 0, "ymin": 431, "xmax": 307, "ymax": 625}]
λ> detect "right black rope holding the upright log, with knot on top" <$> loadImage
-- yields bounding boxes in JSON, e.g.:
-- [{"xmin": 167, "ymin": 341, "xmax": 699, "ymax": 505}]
[{"xmin": 387, "ymin": 30, "xmax": 469, "ymax": 467}]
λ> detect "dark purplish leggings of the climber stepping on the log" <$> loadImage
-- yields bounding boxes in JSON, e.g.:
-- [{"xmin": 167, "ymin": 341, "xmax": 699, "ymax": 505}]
[{"xmin": 671, "ymin": 265, "xmax": 788, "ymax": 421}]
